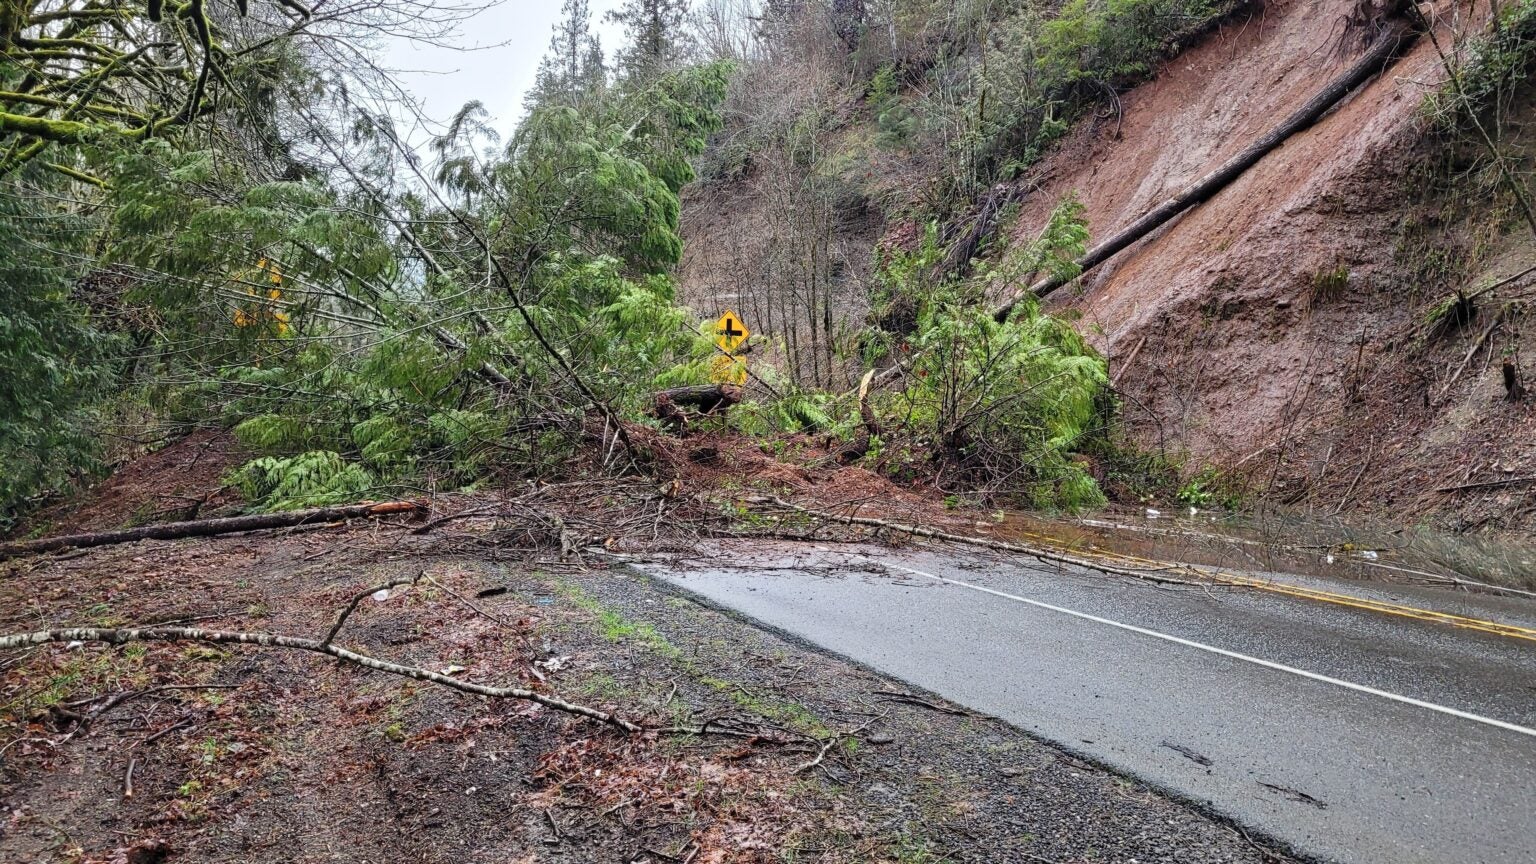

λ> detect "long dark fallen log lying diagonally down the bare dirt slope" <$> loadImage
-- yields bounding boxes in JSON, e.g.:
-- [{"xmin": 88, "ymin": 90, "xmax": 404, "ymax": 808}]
[{"xmin": 992, "ymin": 20, "xmax": 1419, "ymax": 323}]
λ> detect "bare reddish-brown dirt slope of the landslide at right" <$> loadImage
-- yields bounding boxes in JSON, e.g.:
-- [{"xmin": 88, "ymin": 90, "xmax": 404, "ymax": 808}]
[{"xmin": 1017, "ymin": 0, "xmax": 1533, "ymax": 529}]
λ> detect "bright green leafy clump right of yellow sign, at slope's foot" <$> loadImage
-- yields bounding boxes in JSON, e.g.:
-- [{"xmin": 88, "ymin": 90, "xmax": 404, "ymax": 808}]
[{"xmin": 882, "ymin": 198, "xmax": 1107, "ymax": 509}]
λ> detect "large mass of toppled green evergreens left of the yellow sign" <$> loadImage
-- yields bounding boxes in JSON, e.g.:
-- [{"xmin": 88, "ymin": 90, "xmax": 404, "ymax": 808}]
[{"xmin": 76, "ymin": 53, "xmax": 731, "ymax": 507}]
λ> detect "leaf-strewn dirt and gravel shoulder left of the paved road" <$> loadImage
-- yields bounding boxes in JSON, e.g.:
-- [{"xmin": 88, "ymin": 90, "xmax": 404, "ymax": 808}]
[{"xmin": 0, "ymin": 510, "xmax": 1284, "ymax": 864}]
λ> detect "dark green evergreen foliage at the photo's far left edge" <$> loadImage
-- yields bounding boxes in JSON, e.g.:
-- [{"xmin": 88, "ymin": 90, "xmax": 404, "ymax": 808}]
[{"xmin": 0, "ymin": 181, "xmax": 112, "ymax": 530}]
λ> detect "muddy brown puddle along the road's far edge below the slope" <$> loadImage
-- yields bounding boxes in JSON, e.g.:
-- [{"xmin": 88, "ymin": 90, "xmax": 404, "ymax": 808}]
[{"xmin": 991, "ymin": 507, "xmax": 1536, "ymax": 592}]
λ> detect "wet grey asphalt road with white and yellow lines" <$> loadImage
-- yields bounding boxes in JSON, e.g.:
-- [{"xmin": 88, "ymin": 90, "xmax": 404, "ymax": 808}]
[{"xmin": 644, "ymin": 544, "xmax": 1536, "ymax": 864}]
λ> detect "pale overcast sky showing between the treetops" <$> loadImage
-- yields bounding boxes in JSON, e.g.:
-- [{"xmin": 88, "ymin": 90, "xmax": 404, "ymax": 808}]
[{"xmin": 382, "ymin": 0, "xmax": 622, "ymax": 138}]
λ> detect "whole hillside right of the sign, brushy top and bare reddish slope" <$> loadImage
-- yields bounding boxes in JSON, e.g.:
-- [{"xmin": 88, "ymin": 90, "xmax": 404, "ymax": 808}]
[{"xmin": 680, "ymin": 0, "xmax": 1536, "ymax": 530}]
